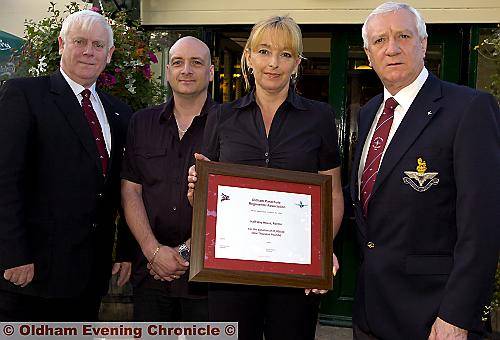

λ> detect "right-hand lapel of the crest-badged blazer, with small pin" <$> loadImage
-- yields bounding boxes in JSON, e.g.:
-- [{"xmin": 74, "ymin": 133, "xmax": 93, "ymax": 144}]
[{"xmin": 372, "ymin": 73, "xmax": 441, "ymax": 197}]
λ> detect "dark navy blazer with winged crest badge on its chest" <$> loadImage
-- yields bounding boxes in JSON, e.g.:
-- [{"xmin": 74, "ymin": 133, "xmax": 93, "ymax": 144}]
[{"xmin": 351, "ymin": 74, "xmax": 500, "ymax": 339}]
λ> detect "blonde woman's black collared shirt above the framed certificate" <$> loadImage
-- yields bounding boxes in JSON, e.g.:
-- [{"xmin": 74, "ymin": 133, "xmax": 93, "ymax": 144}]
[{"xmin": 203, "ymin": 88, "xmax": 340, "ymax": 172}]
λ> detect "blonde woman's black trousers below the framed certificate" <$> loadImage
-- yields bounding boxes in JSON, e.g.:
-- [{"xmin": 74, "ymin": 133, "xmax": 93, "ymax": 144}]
[{"xmin": 208, "ymin": 284, "xmax": 320, "ymax": 340}]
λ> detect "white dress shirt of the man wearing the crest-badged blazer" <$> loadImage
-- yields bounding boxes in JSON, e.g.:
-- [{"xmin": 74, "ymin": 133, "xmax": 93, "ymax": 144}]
[{"xmin": 358, "ymin": 67, "xmax": 429, "ymax": 198}]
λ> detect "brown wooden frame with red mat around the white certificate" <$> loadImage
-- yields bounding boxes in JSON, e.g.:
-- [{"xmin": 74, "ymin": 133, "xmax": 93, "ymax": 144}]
[{"xmin": 189, "ymin": 161, "xmax": 333, "ymax": 289}]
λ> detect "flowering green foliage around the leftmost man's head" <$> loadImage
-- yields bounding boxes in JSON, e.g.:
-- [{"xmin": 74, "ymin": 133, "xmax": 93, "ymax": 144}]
[{"xmin": 16, "ymin": 2, "xmax": 166, "ymax": 110}]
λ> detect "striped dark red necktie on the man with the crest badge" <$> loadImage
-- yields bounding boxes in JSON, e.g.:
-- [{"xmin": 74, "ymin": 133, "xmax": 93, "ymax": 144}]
[{"xmin": 360, "ymin": 97, "xmax": 398, "ymax": 216}]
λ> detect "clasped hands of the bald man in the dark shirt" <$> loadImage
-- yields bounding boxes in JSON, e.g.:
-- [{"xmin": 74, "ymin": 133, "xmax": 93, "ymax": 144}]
[{"xmin": 148, "ymin": 246, "xmax": 189, "ymax": 281}]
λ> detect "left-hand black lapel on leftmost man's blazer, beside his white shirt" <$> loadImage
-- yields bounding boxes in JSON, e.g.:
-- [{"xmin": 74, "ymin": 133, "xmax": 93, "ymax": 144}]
[{"xmin": 50, "ymin": 70, "xmax": 102, "ymax": 171}]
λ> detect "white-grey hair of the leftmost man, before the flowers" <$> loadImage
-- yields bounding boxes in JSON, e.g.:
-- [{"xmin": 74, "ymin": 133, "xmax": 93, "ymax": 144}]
[{"xmin": 59, "ymin": 9, "xmax": 114, "ymax": 50}]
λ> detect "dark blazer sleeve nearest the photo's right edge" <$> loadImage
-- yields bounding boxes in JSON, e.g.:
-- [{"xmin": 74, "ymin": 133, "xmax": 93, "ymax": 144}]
[{"xmin": 438, "ymin": 93, "xmax": 500, "ymax": 330}]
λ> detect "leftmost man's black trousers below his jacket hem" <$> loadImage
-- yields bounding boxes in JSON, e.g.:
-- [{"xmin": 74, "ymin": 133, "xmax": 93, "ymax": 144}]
[{"xmin": 0, "ymin": 290, "xmax": 102, "ymax": 322}]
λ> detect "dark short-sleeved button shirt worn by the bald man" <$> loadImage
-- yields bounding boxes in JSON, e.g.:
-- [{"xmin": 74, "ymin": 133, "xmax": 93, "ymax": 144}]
[{"xmin": 121, "ymin": 97, "xmax": 218, "ymax": 296}]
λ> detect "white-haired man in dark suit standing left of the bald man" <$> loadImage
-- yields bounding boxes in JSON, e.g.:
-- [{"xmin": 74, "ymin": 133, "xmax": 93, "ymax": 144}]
[{"xmin": 0, "ymin": 10, "xmax": 131, "ymax": 321}]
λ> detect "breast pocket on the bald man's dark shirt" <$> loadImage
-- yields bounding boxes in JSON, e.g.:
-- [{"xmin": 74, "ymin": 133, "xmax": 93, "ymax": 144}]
[{"xmin": 135, "ymin": 148, "xmax": 168, "ymax": 184}]
